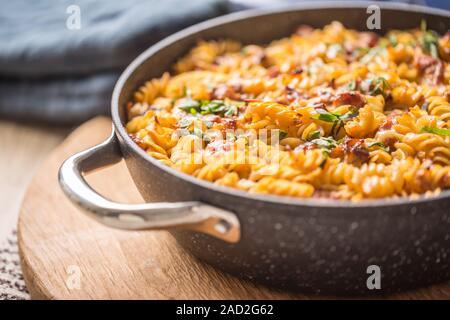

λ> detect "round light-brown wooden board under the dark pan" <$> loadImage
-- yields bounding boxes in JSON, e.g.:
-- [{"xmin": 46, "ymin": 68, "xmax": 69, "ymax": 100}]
[{"xmin": 18, "ymin": 118, "xmax": 450, "ymax": 299}]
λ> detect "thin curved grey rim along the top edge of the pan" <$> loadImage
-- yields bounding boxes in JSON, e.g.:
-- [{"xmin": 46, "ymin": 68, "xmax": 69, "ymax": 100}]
[{"xmin": 111, "ymin": 1, "xmax": 450, "ymax": 209}]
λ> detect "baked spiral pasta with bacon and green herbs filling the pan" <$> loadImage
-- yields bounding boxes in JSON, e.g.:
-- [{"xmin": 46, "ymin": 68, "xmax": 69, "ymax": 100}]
[{"xmin": 126, "ymin": 22, "xmax": 450, "ymax": 201}]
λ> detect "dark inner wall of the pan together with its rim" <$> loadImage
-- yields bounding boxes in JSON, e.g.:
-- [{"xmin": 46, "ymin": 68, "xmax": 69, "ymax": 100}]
[{"xmin": 111, "ymin": 2, "xmax": 450, "ymax": 207}]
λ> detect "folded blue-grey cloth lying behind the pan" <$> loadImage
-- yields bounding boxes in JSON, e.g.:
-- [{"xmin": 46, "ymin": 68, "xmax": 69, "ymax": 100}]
[{"xmin": 0, "ymin": 0, "xmax": 228, "ymax": 123}]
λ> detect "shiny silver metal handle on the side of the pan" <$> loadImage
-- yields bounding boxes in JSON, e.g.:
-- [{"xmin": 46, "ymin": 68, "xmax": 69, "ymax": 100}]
[{"xmin": 59, "ymin": 130, "xmax": 240, "ymax": 243}]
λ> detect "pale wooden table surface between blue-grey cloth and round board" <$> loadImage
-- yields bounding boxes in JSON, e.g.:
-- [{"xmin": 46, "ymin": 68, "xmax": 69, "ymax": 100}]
[{"xmin": 0, "ymin": 120, "xmax": 72, "ymax": 243}]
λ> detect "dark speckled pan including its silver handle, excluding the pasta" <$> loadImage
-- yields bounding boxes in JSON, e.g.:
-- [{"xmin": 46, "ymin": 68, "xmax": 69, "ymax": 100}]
[{"xmin": 59, "ymin": 2, "xmax": 450, "ymax": 294}]
